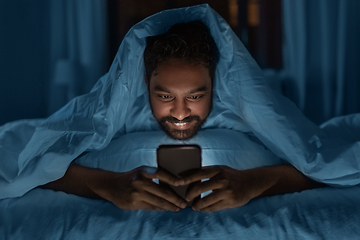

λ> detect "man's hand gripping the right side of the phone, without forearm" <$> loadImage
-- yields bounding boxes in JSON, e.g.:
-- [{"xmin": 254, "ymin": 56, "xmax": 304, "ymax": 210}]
[{"xmin": 177, "ymin": 166, "xmax": 274, "ymax": 212}]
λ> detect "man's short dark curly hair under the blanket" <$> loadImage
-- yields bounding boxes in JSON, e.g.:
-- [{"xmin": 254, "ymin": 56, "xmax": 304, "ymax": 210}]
[{"xmin": 144, "ymin": 21, "xmax": 219, "ymax": 80}]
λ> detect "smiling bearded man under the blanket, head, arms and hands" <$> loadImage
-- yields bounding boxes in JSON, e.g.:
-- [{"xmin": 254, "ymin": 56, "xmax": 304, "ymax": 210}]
[{"xmin": 43, "ymin": 21, "xmax": 321, "ymax": 212}]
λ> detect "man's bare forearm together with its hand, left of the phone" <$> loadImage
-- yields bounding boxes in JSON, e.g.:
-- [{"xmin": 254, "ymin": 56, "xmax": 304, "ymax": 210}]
[{"xmin": 41, "ymin": 164, "xmax": 186, "ymax": 211}]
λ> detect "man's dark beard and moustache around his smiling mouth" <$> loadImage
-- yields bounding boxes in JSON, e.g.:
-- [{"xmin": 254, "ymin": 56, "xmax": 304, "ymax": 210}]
[{"xmin": 158, "ymin": 115, "xmax": 205, "ymax": 140}]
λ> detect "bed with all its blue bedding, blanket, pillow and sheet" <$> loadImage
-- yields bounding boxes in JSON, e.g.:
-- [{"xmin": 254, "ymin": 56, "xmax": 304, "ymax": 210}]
[{"xmin": 0, "ymin": 5, "xmax": 360, "ymax": 240}]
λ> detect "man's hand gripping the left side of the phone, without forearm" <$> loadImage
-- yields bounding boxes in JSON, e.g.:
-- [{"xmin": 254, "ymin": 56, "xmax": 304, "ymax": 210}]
[{"xmin": 89, "ymin": 166, "xmax": 186, "ymax": 212}]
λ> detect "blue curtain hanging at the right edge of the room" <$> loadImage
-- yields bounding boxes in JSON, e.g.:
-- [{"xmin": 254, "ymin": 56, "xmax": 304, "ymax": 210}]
[{"xmin": 282, "ymin": 0, "xmax": 360, "ymax": 123}]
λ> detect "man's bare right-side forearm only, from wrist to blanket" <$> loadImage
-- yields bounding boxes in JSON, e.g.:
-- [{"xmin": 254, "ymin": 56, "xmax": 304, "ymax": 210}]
[{"xmin": 258, "ymin": 165, "xmax": 325, "ymax": 197}]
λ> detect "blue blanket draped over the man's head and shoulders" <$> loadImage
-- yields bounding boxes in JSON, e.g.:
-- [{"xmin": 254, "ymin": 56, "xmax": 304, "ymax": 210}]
[{"xmin": 0, "ymin": 5, "xmax": 360, "ymax": 199}]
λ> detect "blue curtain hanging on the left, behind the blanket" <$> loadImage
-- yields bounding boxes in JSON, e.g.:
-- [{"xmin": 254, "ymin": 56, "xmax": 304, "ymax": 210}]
[{"xmin": 46, "ymin": 0, "xmax": 109, "ymax": 116}]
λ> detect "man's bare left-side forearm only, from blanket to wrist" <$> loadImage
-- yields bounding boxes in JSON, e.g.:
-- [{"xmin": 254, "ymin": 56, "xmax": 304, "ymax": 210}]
[{"xmin": 40, "ymin": 164, "xmax": 114, "ymax": 198}]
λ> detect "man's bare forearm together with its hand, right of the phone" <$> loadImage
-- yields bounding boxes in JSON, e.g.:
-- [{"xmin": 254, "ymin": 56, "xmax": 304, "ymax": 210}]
[{"xmin": 179, "ymin": 165, "xmax": 325, "ymax": 212}]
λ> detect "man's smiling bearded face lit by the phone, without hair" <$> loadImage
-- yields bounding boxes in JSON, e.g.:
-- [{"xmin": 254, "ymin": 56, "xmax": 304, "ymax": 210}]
[{"xmin": 147, "ymin": 60, "xmax": 212, "ymax": 140}]
